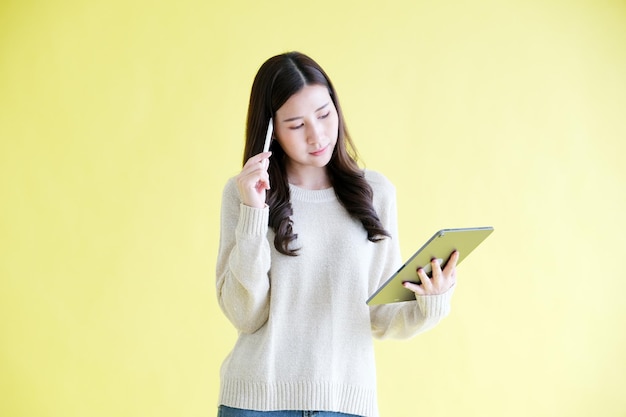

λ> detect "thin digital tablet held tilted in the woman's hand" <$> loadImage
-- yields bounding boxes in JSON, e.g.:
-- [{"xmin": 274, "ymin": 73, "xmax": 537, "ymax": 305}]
[{"xmin": 367, "ymin": 227, "xmax": 493, "ymax": 305}]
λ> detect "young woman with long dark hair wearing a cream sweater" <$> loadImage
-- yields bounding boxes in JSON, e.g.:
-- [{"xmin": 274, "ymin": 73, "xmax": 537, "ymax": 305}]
[{"xmin": 216, "ymin": 52, "xmax": 458, "ymax": 417}]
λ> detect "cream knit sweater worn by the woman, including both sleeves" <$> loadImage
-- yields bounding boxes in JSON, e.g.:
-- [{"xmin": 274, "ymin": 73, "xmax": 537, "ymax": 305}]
[{"xmin": 216, "ymin": 171, "xmax": 453, "ymax": 417}]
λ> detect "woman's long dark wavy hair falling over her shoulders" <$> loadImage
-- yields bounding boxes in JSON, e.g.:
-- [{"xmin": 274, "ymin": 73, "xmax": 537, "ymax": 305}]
[{"xmin": 243, "ymin": 52, "xmax": 390, "ymax": 256}]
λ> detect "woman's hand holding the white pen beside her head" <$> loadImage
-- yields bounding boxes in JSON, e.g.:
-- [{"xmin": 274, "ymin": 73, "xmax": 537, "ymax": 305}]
[{"xmin": 236, "ymin": 152, "xmax": 272, "ymax": 208}]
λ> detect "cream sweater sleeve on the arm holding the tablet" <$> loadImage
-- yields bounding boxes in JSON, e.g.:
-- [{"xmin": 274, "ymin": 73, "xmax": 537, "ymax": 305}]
[{"xmin": 370, "ymin": 171, "xmax": 454, "ymax": 339}]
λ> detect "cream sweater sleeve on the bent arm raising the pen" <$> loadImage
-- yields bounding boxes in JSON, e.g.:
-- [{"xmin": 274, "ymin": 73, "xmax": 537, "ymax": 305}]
[{"xmin": 216, "ymin": 179, "xmax": 271, "ymax": 333}]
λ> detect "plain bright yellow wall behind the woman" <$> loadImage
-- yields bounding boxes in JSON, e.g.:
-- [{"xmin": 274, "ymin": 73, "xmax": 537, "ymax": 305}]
[{"xmin": 0, "ymin": 0, "xmax": 626, "ymax": 417}]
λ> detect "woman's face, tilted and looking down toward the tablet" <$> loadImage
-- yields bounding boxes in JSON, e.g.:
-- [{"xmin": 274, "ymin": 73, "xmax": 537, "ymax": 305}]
[{"xmin": 274, "ymin": 85, "xmax": 339, "ymax": 175}]
